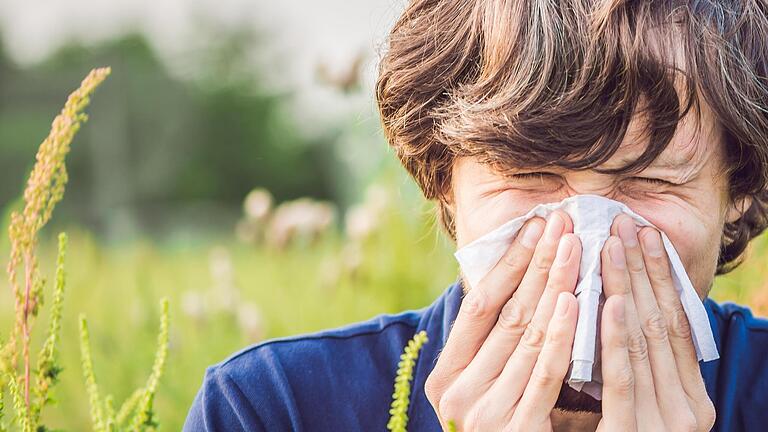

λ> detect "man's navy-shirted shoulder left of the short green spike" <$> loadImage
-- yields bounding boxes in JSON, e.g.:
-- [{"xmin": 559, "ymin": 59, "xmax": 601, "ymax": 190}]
[{"xmin": 185, "ymin": 310, "xmax": 423, "ymax": 431}]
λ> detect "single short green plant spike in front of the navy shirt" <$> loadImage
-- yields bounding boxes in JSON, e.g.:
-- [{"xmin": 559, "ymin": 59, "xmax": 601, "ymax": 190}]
[{"xmin": 387, "ymin": 330, "xmax": 429, "ymax": 432}]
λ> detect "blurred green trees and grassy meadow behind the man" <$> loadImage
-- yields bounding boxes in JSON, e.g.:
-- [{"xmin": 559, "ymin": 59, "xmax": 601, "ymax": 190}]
[{"xmin": 0, "ymin": 5, "xmax": 768, "ymax": 430}]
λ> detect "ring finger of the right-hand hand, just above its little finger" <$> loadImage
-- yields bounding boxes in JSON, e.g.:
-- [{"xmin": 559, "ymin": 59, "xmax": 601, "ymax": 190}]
[{"xmin": 601, "ymin": 240, "xmax": 660, "ymax": 421}]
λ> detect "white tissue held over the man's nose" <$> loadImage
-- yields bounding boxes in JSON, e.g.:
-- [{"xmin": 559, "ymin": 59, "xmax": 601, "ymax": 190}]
[{"xmin": 454, "ymin": 195, "xmax": 719, "ymax": 400}]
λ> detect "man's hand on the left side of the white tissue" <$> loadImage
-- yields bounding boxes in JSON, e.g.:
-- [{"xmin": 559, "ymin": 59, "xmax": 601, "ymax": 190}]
[{"xmin": 425, "ymin": 210, "xmax": 581, "ymax": 431}]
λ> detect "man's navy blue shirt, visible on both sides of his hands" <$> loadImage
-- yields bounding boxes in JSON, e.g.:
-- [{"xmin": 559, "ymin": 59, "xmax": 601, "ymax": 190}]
[{"xmin": 184, "ymin": 282, "xmax": 768, "ymax": 432}]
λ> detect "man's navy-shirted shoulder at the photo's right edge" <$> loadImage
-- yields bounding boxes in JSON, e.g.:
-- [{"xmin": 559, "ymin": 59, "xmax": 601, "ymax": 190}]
[{"xmin": 701, "ymin": 299, "xmax": 768, "ymax": 430}]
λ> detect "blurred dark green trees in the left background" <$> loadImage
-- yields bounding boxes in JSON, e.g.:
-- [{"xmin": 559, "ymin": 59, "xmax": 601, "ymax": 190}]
[{"xmin": 0, "ymin": 29, "xmax": 336, "ymax": 238}]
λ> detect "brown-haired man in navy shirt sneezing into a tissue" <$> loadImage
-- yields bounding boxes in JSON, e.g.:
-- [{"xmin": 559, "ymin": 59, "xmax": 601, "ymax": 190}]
[{"xmin": 185, "ymin": 0, "xmax": 768, "ymax": 431}]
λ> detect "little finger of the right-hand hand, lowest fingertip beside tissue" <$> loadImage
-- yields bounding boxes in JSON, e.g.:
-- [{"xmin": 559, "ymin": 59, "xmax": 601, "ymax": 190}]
[{"xmin": 599, "ymin": 294, "xmax": 637, "ymax": 431}]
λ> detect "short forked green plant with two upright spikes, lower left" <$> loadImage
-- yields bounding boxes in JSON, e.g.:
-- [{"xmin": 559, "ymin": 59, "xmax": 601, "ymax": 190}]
[{"xmin": 80, "ymin": 299, "xmax": 168, "ymax": 432}]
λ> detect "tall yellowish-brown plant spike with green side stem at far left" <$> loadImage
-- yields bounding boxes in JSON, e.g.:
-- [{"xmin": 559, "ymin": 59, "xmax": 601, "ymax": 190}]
[{"xmin": 0, "ymin": 68, "xmax": 110, "ymax": 432}]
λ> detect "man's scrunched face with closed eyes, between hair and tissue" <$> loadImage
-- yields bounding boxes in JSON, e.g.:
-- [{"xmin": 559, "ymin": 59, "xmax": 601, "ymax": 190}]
[{"xmin": 450, "ymin": 100, "xmax": 740, "ymax": 298}]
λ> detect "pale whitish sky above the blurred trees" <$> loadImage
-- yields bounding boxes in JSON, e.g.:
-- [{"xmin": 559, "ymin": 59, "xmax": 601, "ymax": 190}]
[{"xmin": 0, "ymin": 0, "xmax": 405, "ymax": 128}]
